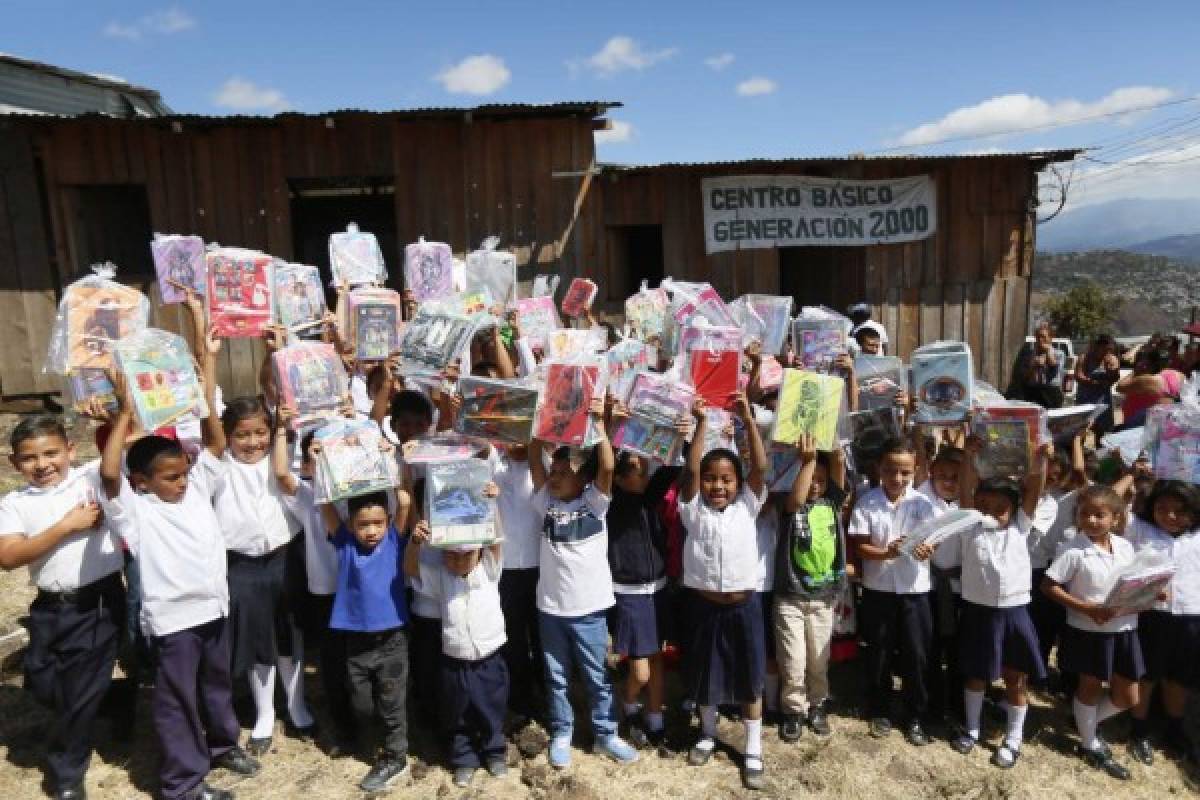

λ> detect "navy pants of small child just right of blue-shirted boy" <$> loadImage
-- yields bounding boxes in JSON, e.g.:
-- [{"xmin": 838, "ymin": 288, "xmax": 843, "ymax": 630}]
[{"xmin": 442, "ymin": 652, "xmax": 509, "ymax": 769}]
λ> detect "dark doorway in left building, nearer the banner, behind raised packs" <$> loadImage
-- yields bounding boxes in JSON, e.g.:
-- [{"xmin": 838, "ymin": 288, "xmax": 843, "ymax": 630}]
[{"xmin": 288, "ymin": 178, "xmax": 402, "ymax": 287}]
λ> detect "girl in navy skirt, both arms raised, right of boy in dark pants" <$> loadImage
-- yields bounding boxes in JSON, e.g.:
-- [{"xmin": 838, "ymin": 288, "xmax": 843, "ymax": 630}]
[{"xmin": 916, "ymin": 438, "xmax": 1050, "ymax": 769}]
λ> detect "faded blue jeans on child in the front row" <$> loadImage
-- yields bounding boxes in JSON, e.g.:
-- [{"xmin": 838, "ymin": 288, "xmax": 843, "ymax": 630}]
[{"xmin": 538, "ymin": 612, "xmax": 617, "ymax": 741}]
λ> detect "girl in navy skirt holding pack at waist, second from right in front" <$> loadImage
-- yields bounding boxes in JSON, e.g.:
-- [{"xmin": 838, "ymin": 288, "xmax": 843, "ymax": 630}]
[{"xmin": 1042, "ymin": 485, "xmax": 1146, "ymax": 781}]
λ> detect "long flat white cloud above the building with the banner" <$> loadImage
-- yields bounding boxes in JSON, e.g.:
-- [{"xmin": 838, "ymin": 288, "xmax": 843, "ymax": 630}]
[{"xmin": 898, "ymin": 86, "xmax": 1175, "ymax": 146}]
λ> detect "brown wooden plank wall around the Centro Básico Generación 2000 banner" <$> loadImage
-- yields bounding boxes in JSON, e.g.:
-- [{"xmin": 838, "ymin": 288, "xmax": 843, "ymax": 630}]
[{"xmin": 590, "ymin": 157, "xmax": 1036, "ymax": 389}]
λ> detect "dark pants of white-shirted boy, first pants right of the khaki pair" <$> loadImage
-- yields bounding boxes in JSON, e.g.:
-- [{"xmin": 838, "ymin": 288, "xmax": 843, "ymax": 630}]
[{"xmin": 859, "ymin": 589, "xmax": 934, "ymax": 720}]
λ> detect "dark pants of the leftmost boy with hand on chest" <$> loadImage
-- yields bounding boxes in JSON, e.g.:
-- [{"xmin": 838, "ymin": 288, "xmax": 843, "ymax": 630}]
[{"xmin": 25, "ymin": 573, "xmax": 125, "ymax": 790}]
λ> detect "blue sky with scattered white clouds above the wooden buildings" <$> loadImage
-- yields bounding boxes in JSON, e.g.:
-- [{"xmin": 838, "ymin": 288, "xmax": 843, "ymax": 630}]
[{"xmin": 0, "ymin": 0, "xmax": 1200, "ymax": 208}]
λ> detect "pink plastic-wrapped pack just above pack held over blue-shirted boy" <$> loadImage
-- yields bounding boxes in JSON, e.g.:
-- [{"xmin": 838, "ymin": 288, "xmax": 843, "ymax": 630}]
[{"xmin": 271, "ymin": 342, "xmax": 350, "ymax": 431}]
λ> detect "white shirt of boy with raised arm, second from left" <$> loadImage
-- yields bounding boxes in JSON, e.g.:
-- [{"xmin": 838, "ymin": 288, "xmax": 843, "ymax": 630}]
[{"xmin": 103, "ymin": 458, "xmax": 229, "ymax": 636}]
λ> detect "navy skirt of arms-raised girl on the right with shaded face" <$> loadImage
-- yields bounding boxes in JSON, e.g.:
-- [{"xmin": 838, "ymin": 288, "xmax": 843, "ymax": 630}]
[{"xmin": 959, "ymin": 601, "xmax": 1046, "ymax": 682}]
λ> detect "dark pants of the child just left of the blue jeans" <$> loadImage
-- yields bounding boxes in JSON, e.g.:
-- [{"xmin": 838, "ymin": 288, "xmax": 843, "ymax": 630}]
[{"xmin": 500, "ymin": 567, "xmax": 546, "ymax": 717}]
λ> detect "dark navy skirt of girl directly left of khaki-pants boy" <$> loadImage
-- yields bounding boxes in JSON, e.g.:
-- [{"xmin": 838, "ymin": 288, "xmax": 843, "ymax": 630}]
[{"xmin": 686, "ymin": 591, "xmax": 767, "ymax": 705}]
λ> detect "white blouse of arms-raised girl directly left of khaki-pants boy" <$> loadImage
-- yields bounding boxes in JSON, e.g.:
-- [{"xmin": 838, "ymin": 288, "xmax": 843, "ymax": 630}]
[{"xmin": 679, "ymin": 486, "xmax": 767, "ymax": 591}]
